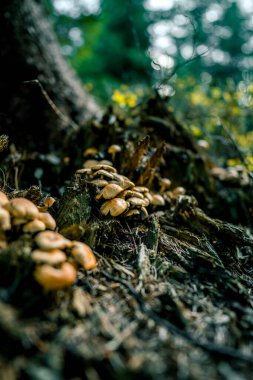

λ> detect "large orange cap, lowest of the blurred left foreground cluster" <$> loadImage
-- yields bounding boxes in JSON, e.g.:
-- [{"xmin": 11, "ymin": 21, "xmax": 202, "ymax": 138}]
[{"xmin": 34, "ymin": 262, "xmax": 77, "ymax": 290}]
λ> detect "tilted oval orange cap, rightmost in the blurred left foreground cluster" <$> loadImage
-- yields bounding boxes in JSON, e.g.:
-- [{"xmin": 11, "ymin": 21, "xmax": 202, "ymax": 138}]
[{"xmin": 70, "ymin": 241, "xmax": 97, "ymax": 270}]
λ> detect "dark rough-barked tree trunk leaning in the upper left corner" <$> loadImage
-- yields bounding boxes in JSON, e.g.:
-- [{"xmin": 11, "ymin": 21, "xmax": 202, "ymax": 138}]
[{"xmin": 0, "ymin": 0, "xmax": 99, "ymax": 152}]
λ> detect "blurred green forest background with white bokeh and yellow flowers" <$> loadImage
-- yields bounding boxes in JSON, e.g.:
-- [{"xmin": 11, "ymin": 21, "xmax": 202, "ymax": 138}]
[{"xmin": 45, "ymin": 0, "xmax": 253, "ymax": 167}]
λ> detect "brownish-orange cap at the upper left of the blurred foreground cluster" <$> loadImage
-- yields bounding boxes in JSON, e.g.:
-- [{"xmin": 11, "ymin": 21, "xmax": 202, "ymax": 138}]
[{"xmin": 3, "ymin": 198, "xmax": 39, "ymax": 220}]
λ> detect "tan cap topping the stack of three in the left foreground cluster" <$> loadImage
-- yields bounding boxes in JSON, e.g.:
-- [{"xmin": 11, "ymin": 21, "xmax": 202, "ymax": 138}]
[{"xmin": 34, "ymin": 231, "xmax": 72, "ymax": 251}]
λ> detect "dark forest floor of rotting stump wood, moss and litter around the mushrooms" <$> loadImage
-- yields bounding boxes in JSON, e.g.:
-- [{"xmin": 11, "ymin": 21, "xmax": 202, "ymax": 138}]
[{"xmin": 0, "ymin": 95, "xmax": 253, "ymax": 380}]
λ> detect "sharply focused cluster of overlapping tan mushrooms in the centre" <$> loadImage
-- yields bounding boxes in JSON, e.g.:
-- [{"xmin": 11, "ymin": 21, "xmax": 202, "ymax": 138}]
[{"xmin": 76, "ymin": 163, "xmax": 152, "ymax": 219}]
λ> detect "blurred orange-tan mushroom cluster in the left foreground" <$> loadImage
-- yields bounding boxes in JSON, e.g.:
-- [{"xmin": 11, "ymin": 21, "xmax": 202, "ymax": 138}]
[{"xmin": 0, "ymin": 191, "xmax": 97, "ymax": 290}]
